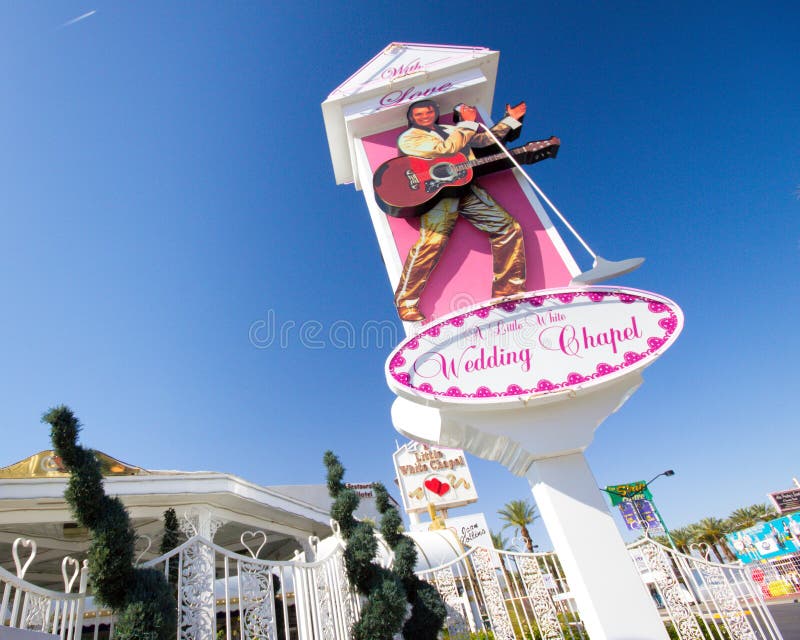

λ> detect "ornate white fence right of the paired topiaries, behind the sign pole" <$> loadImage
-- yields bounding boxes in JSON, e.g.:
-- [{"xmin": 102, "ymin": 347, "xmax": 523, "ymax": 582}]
[{"xmin": 412, "ymin": 539, "xmax": 781, "ymax": 640}]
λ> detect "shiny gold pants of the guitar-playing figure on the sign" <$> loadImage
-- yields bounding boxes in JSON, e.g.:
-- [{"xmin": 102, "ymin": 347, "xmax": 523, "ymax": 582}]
[{"xmin": 394, "ymin": 185, "xmax": 525, "ymax": 309}]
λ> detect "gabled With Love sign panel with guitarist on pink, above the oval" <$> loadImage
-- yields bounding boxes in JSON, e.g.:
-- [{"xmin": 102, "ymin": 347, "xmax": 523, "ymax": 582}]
[{"xmin": 322, "ymin": 42, "xmax": 580, "ymax": 322}]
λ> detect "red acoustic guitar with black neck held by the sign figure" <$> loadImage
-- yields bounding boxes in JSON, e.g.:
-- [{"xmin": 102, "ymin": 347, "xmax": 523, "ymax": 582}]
[{"xmin": 372, "ymin": 136, "xmax": 561, "ymax": 218}]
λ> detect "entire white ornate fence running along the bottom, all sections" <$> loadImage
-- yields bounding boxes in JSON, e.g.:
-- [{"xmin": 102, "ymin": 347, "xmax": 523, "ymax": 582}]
[{"xmin": 0, "ymin": 532, "xmax": 781, "ymax": 640}]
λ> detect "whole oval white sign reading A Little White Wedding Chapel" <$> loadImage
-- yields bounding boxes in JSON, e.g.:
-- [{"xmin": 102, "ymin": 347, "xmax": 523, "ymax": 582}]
[{"xmin": 386, "ymin": 287, "xmax": 683, "ymax": 404}]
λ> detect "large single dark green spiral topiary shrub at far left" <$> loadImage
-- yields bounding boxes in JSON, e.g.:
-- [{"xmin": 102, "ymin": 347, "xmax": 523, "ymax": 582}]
[{"xmin": 42, "ymin": 406, "xmax": 177, "ymax": 640}]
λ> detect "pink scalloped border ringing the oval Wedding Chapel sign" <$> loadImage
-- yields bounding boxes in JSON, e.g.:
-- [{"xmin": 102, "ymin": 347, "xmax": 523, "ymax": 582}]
[{"xmin": 389, "ymin": 291, "xmax": 678, "ymax": 398}]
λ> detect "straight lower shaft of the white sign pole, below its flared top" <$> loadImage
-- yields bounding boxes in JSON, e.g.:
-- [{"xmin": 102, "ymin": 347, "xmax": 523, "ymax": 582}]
[{"xmin": 525, "ymin": 453, "xmax": 668, "ymax": 640}]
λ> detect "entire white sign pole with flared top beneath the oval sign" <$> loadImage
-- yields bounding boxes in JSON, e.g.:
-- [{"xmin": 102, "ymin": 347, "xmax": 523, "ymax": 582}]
[{"xmin": 392, "ymin": 371, "xmax": 668, "ymax": 640}]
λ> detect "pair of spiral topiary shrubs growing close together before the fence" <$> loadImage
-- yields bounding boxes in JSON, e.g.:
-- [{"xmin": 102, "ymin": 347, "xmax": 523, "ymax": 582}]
[{"xmin": 323, "ymin": 451, "xmax": 447, "ymax": 640}]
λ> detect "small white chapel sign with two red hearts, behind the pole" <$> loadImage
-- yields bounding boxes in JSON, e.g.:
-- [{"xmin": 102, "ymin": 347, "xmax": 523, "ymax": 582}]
[{"xmin": 392, "ymin": 442, "xmax": 478, "ymax": 513}]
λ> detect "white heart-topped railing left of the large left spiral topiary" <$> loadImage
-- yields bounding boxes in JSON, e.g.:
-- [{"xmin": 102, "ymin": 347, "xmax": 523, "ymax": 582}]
[{"xmin": 0, "ymin": 538, "xmax": 88, "ymax": 640}]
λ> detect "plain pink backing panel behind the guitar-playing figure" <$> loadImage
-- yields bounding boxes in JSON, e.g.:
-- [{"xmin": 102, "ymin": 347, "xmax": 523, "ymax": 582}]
[{"xmin": 362, "ymin": 116, "xmax": 574, "ymax": 321}]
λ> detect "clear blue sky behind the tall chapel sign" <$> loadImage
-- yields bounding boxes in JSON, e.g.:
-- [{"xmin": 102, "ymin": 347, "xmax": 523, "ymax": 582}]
[{"xmin": 0, "ymin": 1, "xmax": 800, "ymax": 548}]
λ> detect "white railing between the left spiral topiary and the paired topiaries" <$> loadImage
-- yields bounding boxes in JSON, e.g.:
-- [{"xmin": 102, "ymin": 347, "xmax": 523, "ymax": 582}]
[{"xmin": 137, "ymin": 532, "xmax": 359, "ymax": 640}]
